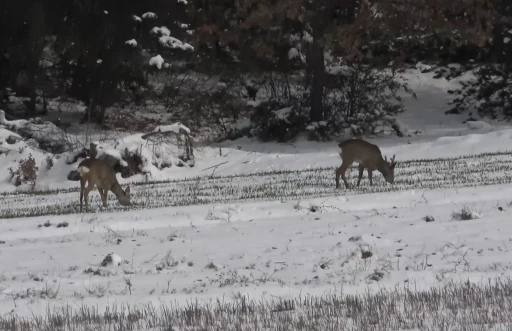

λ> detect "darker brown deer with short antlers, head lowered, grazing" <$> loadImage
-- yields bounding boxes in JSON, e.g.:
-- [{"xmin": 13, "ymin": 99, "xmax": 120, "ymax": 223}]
[{"xmin": 336, "ymin": 139, "xmax": 396, "ymax": 189}]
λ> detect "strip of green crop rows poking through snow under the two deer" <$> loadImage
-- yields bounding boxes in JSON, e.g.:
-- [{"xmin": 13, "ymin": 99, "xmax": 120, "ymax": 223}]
[{"xmin": 0, "ymin": 152, "xmax": 512, "ymax": 218}]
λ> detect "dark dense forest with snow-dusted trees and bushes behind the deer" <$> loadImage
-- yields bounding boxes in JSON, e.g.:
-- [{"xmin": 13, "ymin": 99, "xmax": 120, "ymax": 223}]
[{"xmin": 0, "ymin": 0, "xmax": 512, "ymax": 141}]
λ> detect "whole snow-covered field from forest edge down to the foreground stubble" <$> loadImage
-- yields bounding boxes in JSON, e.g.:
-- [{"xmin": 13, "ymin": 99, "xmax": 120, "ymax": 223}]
[{"xmin": 0, "ymin": 68, "xmax": 512, "ymax": 330}]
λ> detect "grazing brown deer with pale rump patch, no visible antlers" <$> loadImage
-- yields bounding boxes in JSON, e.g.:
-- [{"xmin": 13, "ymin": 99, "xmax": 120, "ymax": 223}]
[{"xmin": 77, "ymin": 159, "xmax": 131, "ymax": 212}]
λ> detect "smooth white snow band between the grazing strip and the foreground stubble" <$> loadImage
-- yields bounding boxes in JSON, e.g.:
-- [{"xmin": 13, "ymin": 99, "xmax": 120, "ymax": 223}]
[{"xmin": 0, "ymin": 182, "xmax": 512, "ymax": 316}]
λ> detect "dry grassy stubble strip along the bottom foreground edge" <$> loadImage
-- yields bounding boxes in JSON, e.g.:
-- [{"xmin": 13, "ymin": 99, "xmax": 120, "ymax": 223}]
[{"xmin": 0, "ymin": 279, "xmax": 512, "ymax": 331}]
